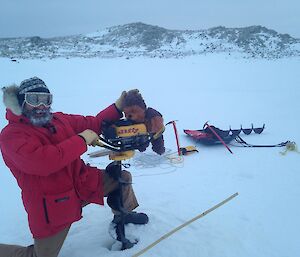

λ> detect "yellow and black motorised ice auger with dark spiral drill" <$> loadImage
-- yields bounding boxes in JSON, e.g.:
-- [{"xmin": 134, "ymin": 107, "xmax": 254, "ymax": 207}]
[{"xmin": 93, "ymin": 120, "xmax": 164, "ymax": 250}]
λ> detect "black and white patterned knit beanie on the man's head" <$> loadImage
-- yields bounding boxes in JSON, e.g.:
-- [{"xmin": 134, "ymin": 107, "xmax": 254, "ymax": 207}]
[{"xmin": 17, "ymin": 77, "xmax": 50, "ymax": 106}]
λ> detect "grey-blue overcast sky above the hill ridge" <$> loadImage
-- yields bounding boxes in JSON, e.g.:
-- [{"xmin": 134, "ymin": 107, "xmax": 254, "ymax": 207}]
[{"xmin": 0, "ymin": 0, "xmax": 300, "ymax": 38}]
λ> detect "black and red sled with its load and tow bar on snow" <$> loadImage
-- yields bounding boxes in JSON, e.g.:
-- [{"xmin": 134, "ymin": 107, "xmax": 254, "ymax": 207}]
[{"xmin": 184, "ymin": 122, "xmax": 291, "ymax": 153}]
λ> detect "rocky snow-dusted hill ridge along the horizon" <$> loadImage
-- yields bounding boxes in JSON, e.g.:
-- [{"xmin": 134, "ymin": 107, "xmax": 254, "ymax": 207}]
[{"xmin": 0, "ymin": 22, "xmax": 300, "ymax": 59}]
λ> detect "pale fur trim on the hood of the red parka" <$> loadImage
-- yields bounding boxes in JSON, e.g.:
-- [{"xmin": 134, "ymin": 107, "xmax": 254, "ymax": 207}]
[{"xmin": 2, "ymin": 84, "xmax": 22, "ymax": 115}]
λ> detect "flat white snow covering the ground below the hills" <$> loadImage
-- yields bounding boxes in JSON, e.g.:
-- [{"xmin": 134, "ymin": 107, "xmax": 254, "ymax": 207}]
[{"xmin": 0, "ymin": 54, "xmax": 300, "ymax": 257}]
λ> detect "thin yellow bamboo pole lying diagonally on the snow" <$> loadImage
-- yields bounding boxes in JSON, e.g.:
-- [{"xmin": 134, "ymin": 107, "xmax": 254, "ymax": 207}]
[{"xmin": 132, "ymin": 192, "xmax": 239, "ymax": 257}]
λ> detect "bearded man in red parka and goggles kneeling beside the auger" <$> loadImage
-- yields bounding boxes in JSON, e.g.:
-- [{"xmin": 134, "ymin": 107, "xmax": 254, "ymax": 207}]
[{"xmin": 0, "ymin": 77, "xmax": 148, "ymax": 257}]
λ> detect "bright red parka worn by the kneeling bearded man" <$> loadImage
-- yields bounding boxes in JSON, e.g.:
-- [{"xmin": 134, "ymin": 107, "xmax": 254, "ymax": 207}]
[{"xmin": 0, "ymin": 105, "xmax": 120, "ymax": 239}]
